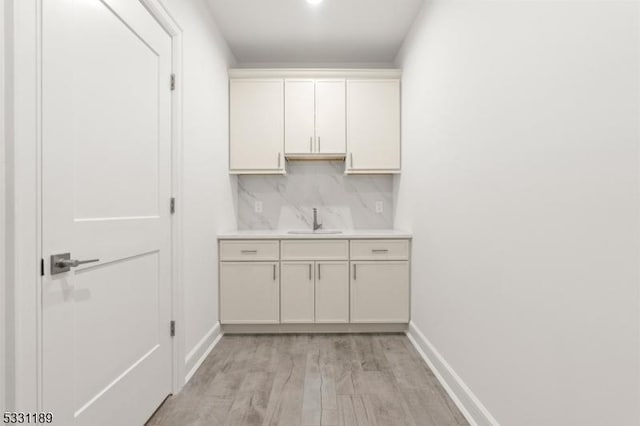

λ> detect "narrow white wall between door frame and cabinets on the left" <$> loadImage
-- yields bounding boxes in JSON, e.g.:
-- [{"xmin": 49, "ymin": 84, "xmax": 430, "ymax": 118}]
[{"xmin": 163, "ymin": 0, "xmax": 236, "ymax": 380}]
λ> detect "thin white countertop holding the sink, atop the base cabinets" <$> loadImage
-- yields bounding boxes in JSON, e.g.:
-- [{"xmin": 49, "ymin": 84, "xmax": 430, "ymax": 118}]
[{"xmin": 218, "ymin": 229, "xmax": 413, "ymax": 240}]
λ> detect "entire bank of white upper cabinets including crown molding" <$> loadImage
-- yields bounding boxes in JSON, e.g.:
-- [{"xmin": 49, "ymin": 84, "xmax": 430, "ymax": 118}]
[{"xmin": 229, "ymin": 69, "xmax": 401, "ymax": 174}]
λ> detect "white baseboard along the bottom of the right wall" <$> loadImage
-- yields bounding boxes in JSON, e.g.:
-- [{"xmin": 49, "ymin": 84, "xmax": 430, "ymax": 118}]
[{"xmin": 407, "ymin": 322, "xmax": 500, "ymax": 426}]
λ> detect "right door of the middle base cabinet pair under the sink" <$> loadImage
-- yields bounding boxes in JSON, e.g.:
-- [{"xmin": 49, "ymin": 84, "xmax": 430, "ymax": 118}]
[{"xmin": 316, "ymin": 262, "xmax": 349, "ymax": 323}]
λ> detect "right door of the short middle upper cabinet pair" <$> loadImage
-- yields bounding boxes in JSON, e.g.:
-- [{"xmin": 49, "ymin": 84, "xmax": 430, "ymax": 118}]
[{"xmin": 316, "ymin": 80, "xmax": 346, "ymax": 155}]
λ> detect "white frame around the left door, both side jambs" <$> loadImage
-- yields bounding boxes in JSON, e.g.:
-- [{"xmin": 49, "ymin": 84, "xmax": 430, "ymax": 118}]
[{"xmin": 7, "ymin": 0, "xmax": 185, "ymax": 414}]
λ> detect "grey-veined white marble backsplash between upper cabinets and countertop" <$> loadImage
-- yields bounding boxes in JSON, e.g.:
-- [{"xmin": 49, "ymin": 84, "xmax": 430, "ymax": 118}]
[{"xmin": 238, "ymin": 161, "xmax": 393, "ymax": 230}]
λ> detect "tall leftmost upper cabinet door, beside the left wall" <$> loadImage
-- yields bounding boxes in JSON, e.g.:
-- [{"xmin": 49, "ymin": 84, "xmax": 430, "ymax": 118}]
[{"xmin": 229, "ymin": 79, "xmax": 284, "ymax": 173}]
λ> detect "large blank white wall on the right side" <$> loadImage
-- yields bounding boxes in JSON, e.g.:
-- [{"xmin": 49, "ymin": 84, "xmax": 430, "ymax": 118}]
[{"xmin": 396, "ymin": 0, "xmax": 640, "ymax": 426}]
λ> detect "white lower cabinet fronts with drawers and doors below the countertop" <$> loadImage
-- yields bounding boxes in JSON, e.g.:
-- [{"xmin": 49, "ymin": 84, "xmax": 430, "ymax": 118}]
[{"xmin": 220, "ymin": 239, "xmax": 410, "ymax": 327}]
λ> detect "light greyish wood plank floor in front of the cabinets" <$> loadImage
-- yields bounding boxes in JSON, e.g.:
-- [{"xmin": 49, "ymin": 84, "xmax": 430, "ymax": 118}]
[{"xmin": 147, "ymin": 334, "xmax": 468, "ymax": 426}]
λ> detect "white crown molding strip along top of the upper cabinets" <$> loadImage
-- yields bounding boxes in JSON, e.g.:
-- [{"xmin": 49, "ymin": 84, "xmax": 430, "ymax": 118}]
[{"xmin": 229, "ymin": 68, "xmax": 402, "ymax": 79}]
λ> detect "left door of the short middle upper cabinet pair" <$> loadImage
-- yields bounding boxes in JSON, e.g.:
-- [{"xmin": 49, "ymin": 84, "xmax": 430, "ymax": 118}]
[{"xmin": 284, "ymin": 80, "xmax": 315, "ymax": 154}]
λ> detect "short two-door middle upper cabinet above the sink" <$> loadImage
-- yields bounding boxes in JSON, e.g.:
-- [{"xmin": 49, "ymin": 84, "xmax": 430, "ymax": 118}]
[{"xmin": 284, "ymin": 79, "xmax": 346, "ymax": 156}]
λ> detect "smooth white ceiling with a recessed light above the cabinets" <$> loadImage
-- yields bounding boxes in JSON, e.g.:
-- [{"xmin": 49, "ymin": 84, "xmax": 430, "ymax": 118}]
[{"xmin": 208, "ymin": 0, "xmax": 423, "ymax": 65}]
